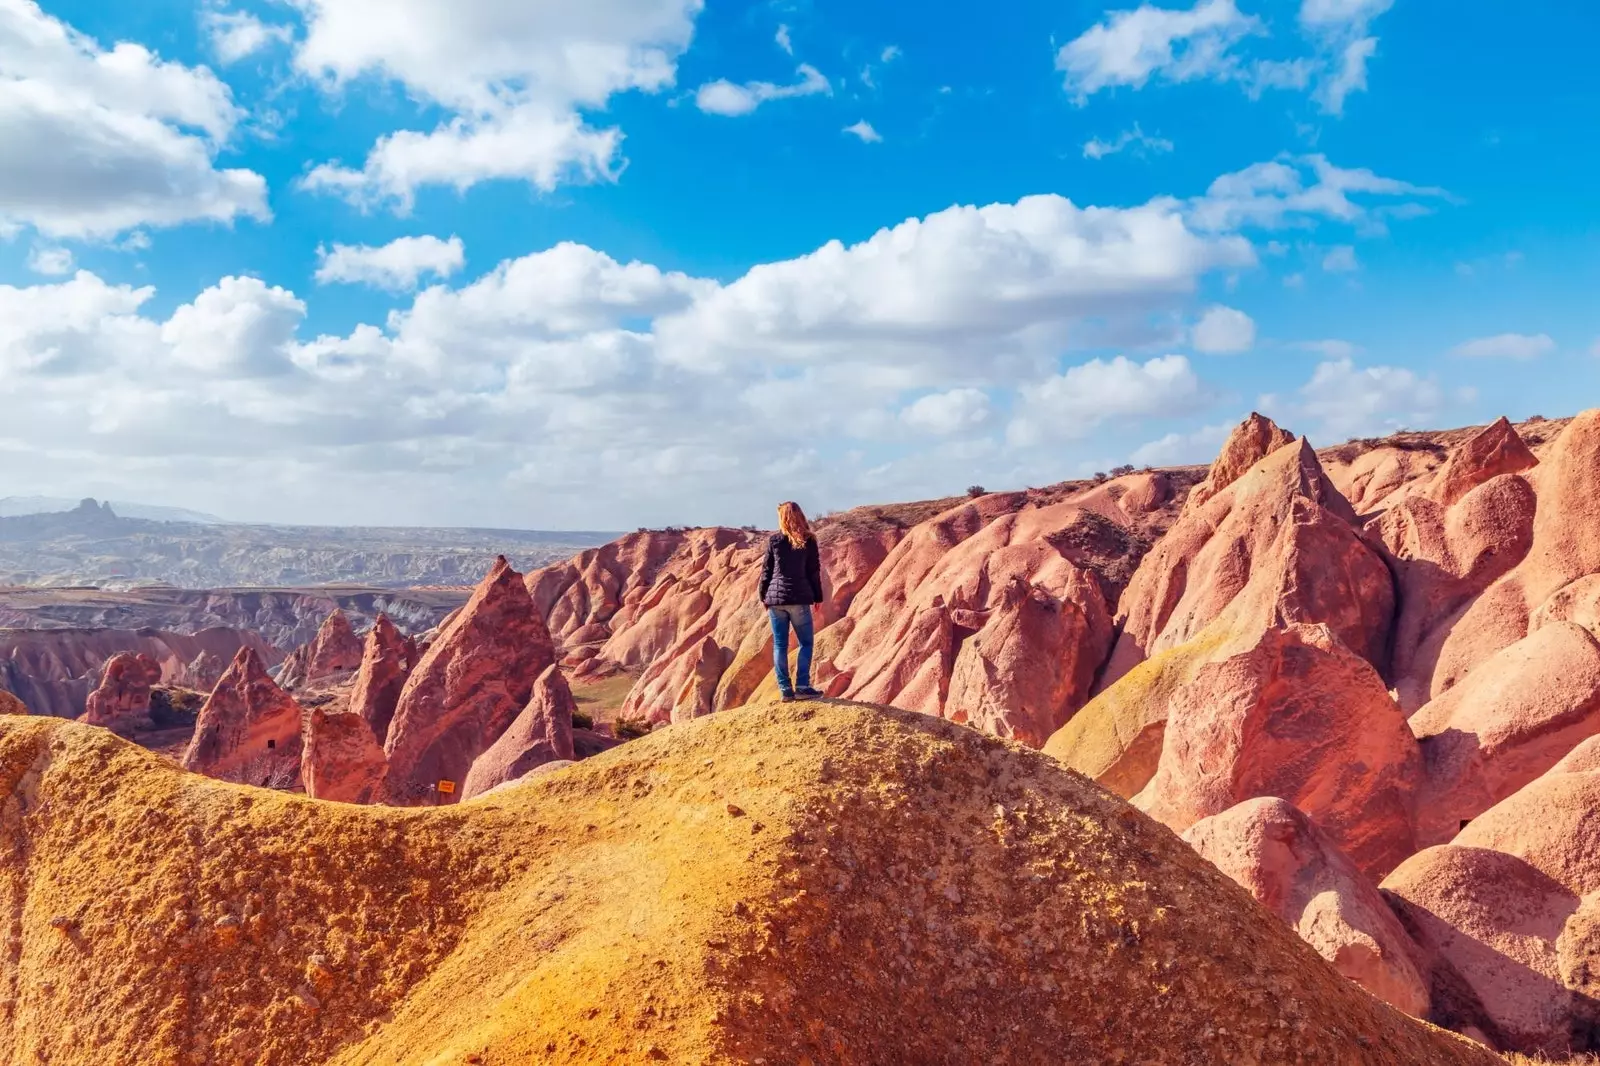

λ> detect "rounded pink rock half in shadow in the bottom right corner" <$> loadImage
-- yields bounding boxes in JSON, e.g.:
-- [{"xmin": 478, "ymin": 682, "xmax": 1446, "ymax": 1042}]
[{"xmin": 1382, "ymin": 845, "xmax": 1589, "ymax": 1055}]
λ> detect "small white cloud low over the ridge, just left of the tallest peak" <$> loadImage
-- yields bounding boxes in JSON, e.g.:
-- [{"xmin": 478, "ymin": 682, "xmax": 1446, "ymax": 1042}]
[{"xmin": 1006, "ymin": 355, "xmax": 1211, "ymax": 447}]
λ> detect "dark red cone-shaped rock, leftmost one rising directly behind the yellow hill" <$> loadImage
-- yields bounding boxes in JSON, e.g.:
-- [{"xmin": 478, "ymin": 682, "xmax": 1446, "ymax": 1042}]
[{"xmin": 182, "ymin": 648, "xmax": 302, "ymax": 787}]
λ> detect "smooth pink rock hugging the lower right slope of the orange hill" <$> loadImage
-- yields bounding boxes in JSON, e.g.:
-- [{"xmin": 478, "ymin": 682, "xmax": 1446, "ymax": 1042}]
[{"xmin": 1184, "ymin": 797, "xmax": 1429, "ymax": 1018}]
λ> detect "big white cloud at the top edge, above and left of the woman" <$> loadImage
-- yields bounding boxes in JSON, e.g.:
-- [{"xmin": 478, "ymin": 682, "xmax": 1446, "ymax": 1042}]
[{"xmin": 293, "ymin": 0, "xmax": 702, "ymax": 211}]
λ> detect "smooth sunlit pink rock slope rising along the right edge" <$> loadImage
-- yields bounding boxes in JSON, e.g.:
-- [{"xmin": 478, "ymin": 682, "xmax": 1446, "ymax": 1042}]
[{"xmin": 1430, "ymin": 410, "xmax": 1600, "ymax": 695}]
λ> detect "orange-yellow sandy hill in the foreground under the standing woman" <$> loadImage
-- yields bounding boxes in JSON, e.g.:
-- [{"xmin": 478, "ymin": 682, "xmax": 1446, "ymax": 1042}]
[{"xmin": 0, "ymin": 704, "xmax": 1498, "ymax": 1066}]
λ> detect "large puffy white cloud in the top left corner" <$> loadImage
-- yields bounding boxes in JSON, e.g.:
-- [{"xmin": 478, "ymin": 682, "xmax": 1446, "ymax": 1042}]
[{"xmin": 0, "ymin": 0, "xmax": 269, "ymax": 237}]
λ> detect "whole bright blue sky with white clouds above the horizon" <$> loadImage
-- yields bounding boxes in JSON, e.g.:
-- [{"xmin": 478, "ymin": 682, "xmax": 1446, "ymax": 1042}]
[{"xmin": 0, "ymin": 0, "xmax": 1600, "ymax": 530}]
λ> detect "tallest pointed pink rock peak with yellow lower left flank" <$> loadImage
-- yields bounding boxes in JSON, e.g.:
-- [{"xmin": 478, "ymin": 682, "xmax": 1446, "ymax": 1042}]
[{"xmin": 1045, "ymin": 423, "xmax": 1394, "ymax": 795}]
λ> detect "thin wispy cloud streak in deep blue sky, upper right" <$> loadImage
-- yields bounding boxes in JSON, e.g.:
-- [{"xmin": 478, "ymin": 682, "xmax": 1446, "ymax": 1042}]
[{"xmin": 1189, "ymin": 155, "xmax": 1448, "ymax": 230}]
